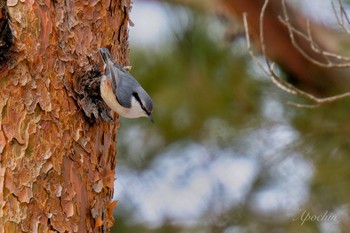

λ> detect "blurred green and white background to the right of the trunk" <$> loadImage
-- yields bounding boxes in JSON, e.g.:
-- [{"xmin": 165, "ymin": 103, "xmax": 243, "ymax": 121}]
[{"xmin": 112, "ymin": 0, "xmax": 350, "ymax": 233}]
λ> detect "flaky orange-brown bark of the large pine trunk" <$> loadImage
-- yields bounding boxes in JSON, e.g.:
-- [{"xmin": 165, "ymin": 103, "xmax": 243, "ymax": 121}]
[{"xmin": 0, "ymin": 0, "xmax": 130, "ymax": 233}]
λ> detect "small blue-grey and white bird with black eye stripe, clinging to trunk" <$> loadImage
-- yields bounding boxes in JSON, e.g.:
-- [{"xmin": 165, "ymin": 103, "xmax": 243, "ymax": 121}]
[{"xmin": 98, "ymin": 48, "xmax": 154, "ymax": 123}]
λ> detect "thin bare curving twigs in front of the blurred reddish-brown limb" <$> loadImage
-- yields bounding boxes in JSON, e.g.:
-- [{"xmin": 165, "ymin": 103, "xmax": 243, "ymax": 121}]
[{"xmin": 243, "ymin": 0, "xmax": 350, "ymax": 108}]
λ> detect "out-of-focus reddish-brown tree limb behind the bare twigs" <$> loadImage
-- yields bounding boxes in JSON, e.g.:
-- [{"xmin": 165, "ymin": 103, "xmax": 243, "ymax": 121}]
[{"xmin": 148, "ymin": 0, "xmax": 350, "ymax": 96}]
